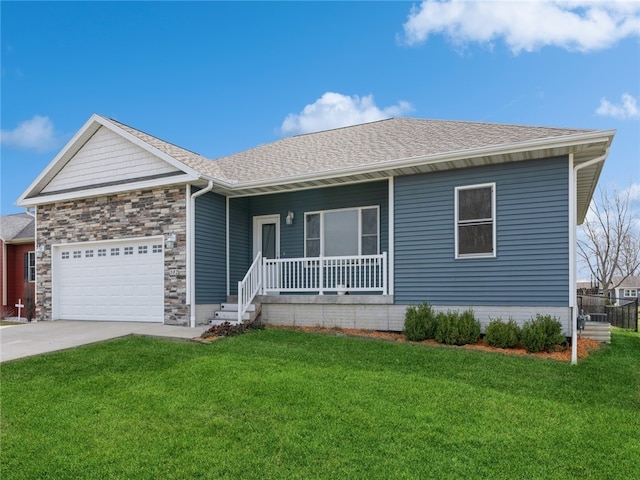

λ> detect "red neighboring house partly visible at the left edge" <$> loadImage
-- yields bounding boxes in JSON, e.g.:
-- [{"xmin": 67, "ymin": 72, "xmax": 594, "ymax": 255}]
[{"xmin": 0, "ymin": 213, "xmax": 36, "ymax": 317}]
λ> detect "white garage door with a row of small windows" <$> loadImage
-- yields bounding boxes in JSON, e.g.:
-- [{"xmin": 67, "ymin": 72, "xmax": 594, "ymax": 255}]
[{"xmin": 53, "ymin": 237, "xmax": 164, "ymax": 322}]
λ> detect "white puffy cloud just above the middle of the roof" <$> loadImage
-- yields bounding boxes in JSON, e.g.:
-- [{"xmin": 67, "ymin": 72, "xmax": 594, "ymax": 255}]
[{"xmin": 280, "ymin": 92, "xmax": 413, "ymax": 135}]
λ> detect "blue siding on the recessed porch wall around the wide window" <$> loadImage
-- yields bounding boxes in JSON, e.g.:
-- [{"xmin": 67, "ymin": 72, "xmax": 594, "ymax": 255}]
[{"xmin": 249, "ymin": 181, "xmax": 389, "ymax": 258}]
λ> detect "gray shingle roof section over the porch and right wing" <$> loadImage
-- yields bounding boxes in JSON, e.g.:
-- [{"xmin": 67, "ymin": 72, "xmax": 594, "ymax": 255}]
[{"xmin": 215, "ymin": 118, "xmax": 590, "ymax": 182}]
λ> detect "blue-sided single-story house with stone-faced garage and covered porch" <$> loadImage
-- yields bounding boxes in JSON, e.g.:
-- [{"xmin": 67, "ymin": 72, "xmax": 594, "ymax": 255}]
[{"xmin": 18, "ymin": 115, "xmax": 614, "ymax": 334}]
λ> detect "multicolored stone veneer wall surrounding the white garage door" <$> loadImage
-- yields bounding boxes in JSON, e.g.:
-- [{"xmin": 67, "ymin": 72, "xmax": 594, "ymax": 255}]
[{"xmin": 36, "ymin": 185, "xmax": 189, "ymax": 325}]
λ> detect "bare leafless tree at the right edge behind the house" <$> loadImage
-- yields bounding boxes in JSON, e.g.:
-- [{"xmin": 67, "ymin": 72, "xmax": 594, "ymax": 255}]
[{"xmin": 578, "ymin": 188, "xmax": 640, "ymax": 297}]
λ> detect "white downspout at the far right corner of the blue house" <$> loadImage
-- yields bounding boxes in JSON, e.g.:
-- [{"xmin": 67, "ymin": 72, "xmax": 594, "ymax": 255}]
[{"xmin": 569, "ymin": 148, "xmax": 609, "ymax": 365}]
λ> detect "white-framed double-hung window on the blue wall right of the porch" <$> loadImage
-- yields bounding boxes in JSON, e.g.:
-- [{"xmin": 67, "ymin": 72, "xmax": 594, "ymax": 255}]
[{"xmin": 455, "ymin": 183, "xmax": 496, "ymax": 258}]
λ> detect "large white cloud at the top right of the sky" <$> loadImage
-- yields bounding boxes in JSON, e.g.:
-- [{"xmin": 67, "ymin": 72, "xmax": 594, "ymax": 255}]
[{"xmin": 402, "ymin": 0, "xmax": 640, "ymax": 54}]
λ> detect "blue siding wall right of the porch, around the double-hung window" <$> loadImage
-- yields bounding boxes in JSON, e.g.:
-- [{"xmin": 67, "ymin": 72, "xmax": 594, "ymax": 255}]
[{"xmin": 395, "ymin": 157, "xmax": 569, "ymax": 306}]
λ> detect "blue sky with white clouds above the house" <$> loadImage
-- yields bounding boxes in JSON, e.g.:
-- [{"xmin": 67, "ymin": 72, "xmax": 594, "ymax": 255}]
[{"xmin": 0, "ymin": 0, "xmax": 640, "ymax": 214}]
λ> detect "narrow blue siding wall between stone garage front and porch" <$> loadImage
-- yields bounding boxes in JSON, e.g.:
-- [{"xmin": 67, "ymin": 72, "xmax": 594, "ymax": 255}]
[{"xmin": 195, "ymin": 193, "xmax": 227, "ymax": 304}]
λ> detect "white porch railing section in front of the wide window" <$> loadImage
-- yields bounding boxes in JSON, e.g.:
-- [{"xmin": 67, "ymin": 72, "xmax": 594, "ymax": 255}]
[{"xmin": 262, "ymin": 252, "xmax": 387, "ymax": 295}]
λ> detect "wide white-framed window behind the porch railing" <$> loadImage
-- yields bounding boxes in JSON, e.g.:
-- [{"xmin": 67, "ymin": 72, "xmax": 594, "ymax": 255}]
[{"xmin": 304, "ymin": 207, "xmax": 380, "ymax": 257}]
